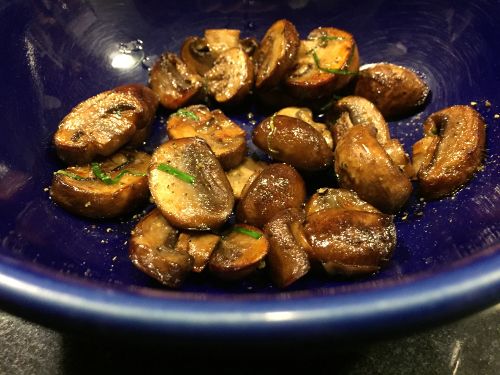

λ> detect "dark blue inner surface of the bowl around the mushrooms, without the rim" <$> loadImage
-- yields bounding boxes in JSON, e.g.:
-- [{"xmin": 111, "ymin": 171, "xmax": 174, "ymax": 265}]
[{"xmin": 0, "ymin": 0, "xmax": 500, "ymax": 298}]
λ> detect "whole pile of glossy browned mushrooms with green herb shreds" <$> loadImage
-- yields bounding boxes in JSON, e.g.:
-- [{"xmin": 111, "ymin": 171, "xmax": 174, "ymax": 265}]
[{"xmin": 50, "ymin": 20, "xmax": 485, "ymax": 288}]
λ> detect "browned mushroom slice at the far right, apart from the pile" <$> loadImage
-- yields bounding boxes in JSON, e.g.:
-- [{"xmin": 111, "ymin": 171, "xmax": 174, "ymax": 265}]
[{"xmin": 413, "ymin": 105, "xmax": 486, "ymax": 199}]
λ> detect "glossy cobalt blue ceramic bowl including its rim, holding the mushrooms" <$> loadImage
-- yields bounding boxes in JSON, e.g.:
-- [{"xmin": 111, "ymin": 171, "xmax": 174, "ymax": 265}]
[{"xmin": 0, "ymin": 0, "xmax": 500, "ymax": 339}]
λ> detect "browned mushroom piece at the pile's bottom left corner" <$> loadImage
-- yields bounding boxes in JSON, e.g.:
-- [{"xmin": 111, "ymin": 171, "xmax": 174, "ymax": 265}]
[{"xmin": 129, "ymin": 209, "xmax": 193, "ymax": 288}]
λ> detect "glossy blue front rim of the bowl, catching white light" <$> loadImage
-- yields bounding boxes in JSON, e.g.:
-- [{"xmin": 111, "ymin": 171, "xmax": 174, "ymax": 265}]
[{"xmin": 0, "ymin": 243, "xmax": 500, "ymax": 339}]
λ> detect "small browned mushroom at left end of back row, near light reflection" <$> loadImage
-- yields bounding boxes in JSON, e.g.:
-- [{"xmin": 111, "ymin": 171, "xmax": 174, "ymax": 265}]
[{"xmin": 149, "ymin": 52, "xmax": 203, "ymax": 109}]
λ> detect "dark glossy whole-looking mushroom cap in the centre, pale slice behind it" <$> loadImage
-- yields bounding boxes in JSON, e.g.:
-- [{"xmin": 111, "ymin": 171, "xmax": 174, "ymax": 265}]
[{"xmin": 252, "ymin": 115, "xmax": 333, "ymax": 171}]
